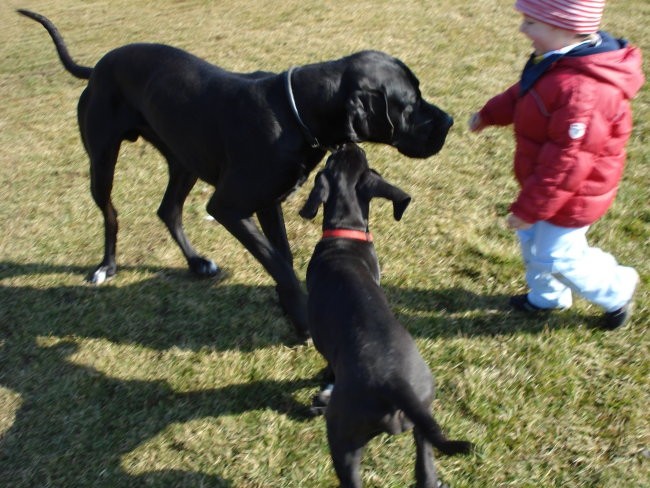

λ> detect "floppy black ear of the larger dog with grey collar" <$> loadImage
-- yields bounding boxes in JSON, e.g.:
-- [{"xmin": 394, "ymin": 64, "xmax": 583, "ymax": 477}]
[{"xmin": 346, "ymin": 90, "xmax": 395, "ymax": 142}]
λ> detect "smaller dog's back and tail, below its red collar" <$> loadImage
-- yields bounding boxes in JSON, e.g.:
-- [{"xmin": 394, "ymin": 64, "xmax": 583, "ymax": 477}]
[{"xmin": 307, "ymin": 239, "xmax": 454, "ymax": 442}]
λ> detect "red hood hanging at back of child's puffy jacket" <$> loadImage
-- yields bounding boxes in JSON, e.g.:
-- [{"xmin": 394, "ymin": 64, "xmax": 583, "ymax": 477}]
[{"xmin": 558, "ymin": 32, "xmax": 645, "ymax": 99}]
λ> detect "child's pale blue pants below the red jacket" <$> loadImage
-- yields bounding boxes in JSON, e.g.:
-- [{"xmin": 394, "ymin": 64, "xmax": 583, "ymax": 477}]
[{"xmin": 517, "ymin": 222, "xmax": 639, "ymax": 312}]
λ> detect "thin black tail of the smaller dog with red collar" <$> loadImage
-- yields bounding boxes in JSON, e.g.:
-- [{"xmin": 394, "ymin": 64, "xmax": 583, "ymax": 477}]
[{"xmin": 392, "ymin": 381, "xmax": 474, "ymax": 456}]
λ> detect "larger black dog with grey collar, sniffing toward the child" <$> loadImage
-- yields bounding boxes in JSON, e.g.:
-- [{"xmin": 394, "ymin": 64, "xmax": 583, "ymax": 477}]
[{"xmin": 18, "ymin": 10, "xmax": 453, "ymax": 335}]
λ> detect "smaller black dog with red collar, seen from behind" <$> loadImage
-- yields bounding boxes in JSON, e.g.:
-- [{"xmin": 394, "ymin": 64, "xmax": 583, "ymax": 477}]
[{"xmin": 300, "ymin": 144, "xmax": 472, "ymax": 488}]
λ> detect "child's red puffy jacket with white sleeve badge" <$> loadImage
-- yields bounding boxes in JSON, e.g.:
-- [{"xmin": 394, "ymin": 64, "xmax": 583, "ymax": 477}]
[{"xmin": 480, "ymin": 46, "xmax": 644, "ymax": 227}]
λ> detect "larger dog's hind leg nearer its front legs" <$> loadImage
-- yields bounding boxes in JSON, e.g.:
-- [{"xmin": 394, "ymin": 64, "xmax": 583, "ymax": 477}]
[{"xmin": 154, "ymin": 158, "xmax": 220, "ymax": 277}]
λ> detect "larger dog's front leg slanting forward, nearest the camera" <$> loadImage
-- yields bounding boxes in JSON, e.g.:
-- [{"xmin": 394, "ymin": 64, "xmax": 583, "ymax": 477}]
[{"xmin": 208, "ymin": 198, "xmax": 309, "ymax": 340}]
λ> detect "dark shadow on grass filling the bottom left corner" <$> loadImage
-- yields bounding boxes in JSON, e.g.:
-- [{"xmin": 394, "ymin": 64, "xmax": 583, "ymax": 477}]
[{"xmin": 0, "ymin": 331, "xmax": 313, "ymax": 488}]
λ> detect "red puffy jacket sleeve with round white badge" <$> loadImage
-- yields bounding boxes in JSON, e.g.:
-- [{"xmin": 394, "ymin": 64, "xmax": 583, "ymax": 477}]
[{"xmin": 510, "ymin": 77, "xmax": 609, "ymax": 223}]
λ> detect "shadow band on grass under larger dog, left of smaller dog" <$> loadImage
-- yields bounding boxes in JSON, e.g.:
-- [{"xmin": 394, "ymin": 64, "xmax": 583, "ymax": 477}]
[{"xmin": 0, "ymin": 262, "xmax": 312, "ymax": 352}]
